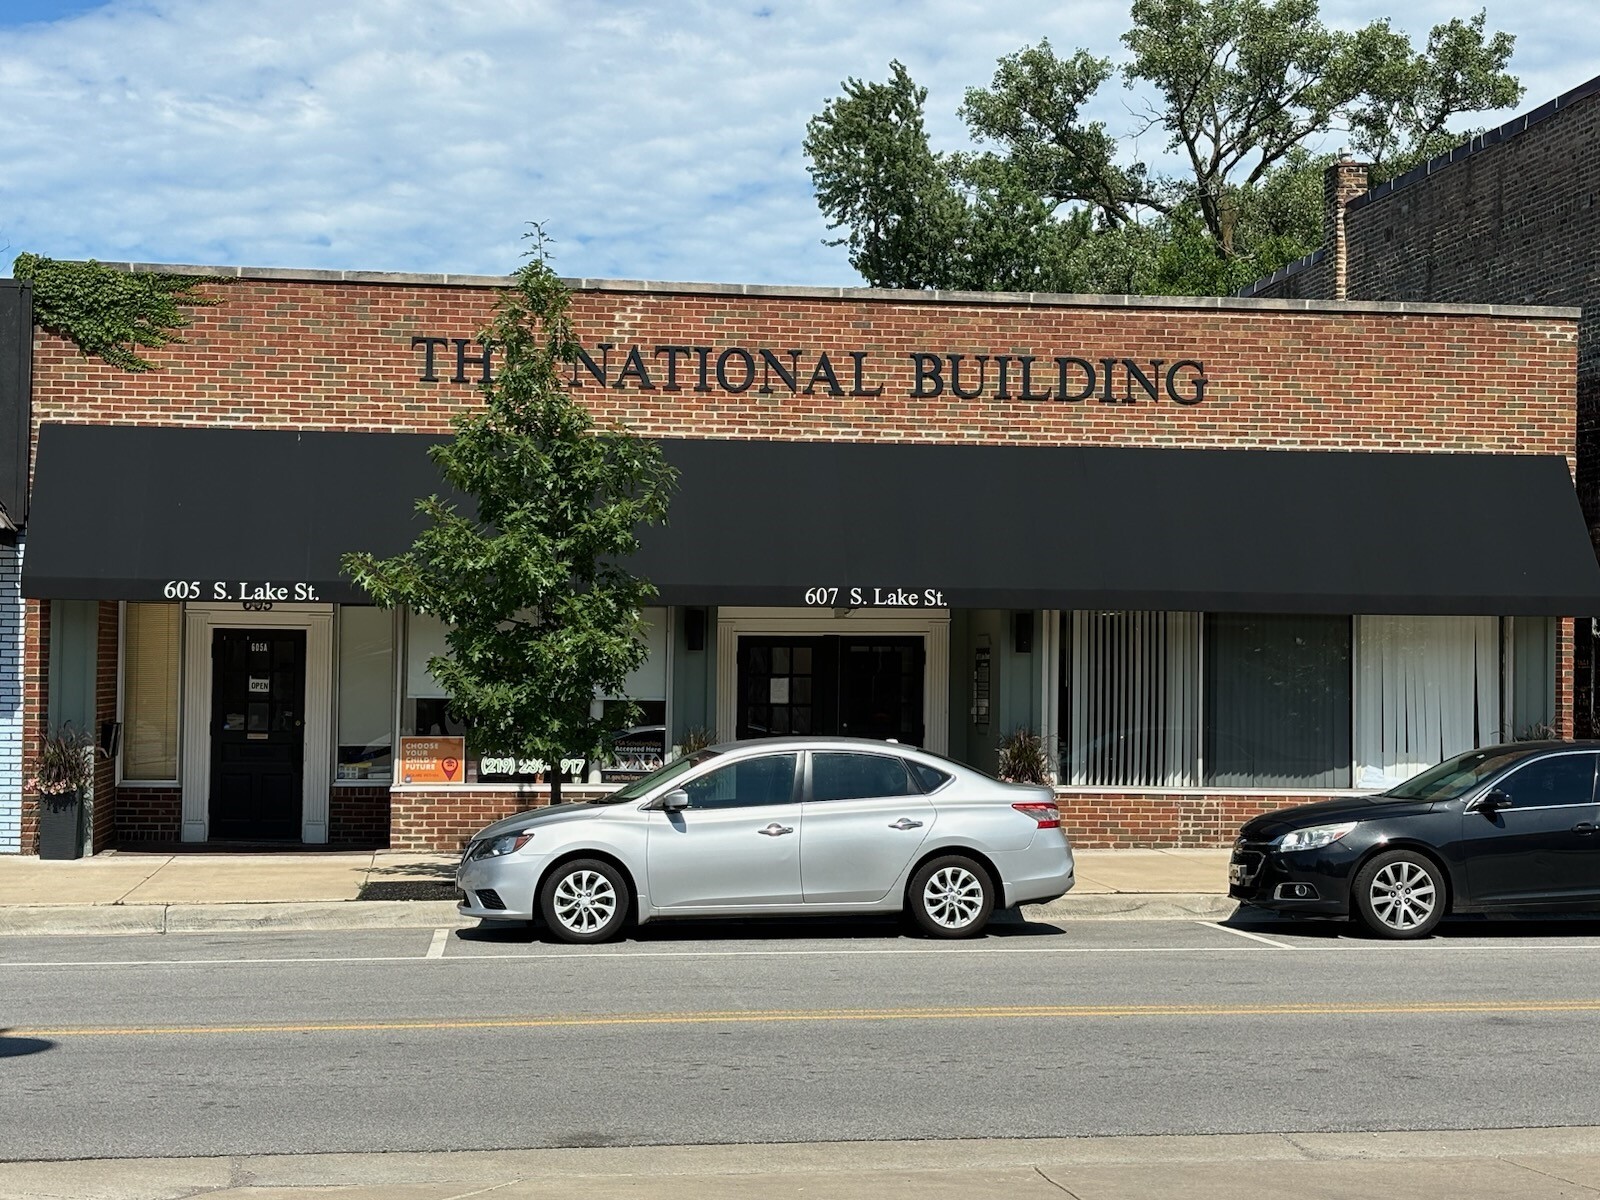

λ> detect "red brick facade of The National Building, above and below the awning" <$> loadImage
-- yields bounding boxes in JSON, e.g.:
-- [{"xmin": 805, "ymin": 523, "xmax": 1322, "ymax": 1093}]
[{"xmin": 15, "ymin": 269, "xmax": 1576, "ymax": 850}]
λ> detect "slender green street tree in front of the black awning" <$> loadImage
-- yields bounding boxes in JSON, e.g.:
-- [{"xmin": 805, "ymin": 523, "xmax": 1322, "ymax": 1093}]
[{"xmin": 342, "ymin": 226, "xmax": 675, "ymax": 803}]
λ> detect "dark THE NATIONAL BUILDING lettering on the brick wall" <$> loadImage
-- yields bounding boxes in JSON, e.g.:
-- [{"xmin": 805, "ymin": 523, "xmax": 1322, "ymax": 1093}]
[{"xmin": 411, "ymin": 336, "xmax": 1210, "ymax": 405}]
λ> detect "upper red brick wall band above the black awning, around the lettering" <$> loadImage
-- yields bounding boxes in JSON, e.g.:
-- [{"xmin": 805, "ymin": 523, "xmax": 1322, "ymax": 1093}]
[{"xmin": 21, "ymin": 280, "xmax": 1576, "ymax": 467}]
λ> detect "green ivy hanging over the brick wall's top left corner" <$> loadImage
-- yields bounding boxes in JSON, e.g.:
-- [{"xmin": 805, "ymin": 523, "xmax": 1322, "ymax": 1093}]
[{"xmin": 11, "ymin": 254, "xmax": 222, "ymax": 371}]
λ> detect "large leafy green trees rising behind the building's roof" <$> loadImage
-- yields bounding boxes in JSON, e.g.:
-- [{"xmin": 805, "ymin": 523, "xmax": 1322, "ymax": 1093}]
[{"xmin": 805, "ymin": 0, "xmax": 1522, "ymax": 293}]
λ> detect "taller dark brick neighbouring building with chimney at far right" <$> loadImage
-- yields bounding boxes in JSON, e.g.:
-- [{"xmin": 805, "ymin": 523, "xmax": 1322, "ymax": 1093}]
[{"xmin": 1242, "ymin": 77, "xmax": 1600, "ymax": 736}]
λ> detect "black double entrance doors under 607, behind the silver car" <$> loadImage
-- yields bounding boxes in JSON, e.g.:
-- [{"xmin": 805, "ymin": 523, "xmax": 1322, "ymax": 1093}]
[{"xmin": 736, "ymin": 637, "xmax": 925, "ymax": 746}]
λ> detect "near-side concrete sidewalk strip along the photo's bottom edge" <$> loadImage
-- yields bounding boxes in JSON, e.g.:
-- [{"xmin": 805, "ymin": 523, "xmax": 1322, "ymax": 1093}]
[{"xmin": 0, "ymin": 1126, "xmax": 1600, "ymax": 1200}]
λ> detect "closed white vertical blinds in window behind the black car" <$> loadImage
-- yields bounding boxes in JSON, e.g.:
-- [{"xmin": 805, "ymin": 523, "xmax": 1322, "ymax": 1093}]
[{"xmin": 1355, "ymin": 616, "xmax": 1501, "ymax": 787}]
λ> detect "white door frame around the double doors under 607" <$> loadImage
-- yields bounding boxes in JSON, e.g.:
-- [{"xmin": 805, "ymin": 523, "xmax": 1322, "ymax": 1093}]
[{"xmin": 717, "ymin": 608, "xmax": 950, "ymax": 754}]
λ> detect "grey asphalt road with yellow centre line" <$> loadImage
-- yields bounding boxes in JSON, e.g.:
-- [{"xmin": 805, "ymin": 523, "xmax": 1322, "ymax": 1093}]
[{"xmin": 0, "ymin": 922, "xmax": 1600, "ymax": 1158}]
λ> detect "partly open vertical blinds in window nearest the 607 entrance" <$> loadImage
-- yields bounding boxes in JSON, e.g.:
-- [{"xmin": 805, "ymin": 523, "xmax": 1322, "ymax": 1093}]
[{"xmin": 1066, "ymin": 611, "xmax": 1200, "ymax": 787}]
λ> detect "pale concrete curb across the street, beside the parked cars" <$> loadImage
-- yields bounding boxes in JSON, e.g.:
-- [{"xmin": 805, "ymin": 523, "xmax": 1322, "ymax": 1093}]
[{"xmin": 0, "ymin": 893, "xmax": 1238, "ymax": 936}]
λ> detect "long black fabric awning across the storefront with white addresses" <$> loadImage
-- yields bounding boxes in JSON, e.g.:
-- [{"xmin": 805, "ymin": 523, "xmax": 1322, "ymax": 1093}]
[{"xmin": 22, "ymin": 426, "xmax": 1600, "ymax": 616}]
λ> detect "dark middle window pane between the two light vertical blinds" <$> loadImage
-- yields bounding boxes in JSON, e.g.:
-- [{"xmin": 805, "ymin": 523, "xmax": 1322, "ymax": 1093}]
[{"xmin": 1203, "ymin": 613, "xmax": 1350, "ymax": 789}]
